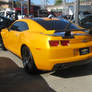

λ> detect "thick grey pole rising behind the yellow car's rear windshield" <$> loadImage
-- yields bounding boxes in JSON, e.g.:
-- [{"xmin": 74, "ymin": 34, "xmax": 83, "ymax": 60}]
[{"xmin": 74, "ymin": 0, "xmax": 80, "ymax": 24}]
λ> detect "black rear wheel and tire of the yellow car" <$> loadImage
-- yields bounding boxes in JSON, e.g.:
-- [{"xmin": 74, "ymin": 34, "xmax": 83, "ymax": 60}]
[{"xmin": 21, "ymin": 46, "xmax": 38, "ymax": 74}]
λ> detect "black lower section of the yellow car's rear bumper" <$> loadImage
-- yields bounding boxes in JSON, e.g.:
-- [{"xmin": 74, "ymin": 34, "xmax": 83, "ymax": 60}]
[{"xmin": 53, "ymin": 58, "xmax": 92, "ymax": 70}]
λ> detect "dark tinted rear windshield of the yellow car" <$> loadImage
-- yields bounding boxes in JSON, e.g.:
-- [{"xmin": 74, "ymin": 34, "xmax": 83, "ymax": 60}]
[{"xmin": 35, "ymin": 19, "xmax": 79, "ymax": 31}]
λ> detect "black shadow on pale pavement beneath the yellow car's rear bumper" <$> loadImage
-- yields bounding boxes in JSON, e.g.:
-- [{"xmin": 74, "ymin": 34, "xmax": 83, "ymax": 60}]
[{"xmin": 51, "ymin": 63, "xmax": 92, "ymax": 78}]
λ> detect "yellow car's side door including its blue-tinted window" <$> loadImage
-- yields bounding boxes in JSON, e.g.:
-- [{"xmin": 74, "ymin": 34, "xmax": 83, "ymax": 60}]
[{"xmin": 8, "ymin": 21, "xmax": 29, "ymax": 54}]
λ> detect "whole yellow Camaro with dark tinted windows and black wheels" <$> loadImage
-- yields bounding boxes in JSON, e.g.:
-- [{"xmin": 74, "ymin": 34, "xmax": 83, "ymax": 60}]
[{"xmin": 1, "ymin": 18, "xmax": 92, "ymax": 73}]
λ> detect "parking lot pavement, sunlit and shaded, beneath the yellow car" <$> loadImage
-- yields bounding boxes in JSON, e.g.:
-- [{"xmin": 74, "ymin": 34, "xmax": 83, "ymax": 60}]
[{"xmin": 0, "ymin": 50, "xmax": 92, "ymax": 92}]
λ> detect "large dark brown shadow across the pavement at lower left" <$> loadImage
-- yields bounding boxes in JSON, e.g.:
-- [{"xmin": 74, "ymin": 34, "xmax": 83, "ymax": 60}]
[{"xmin": 0, "ymin": 57, "xmax": 55, "ymax": 92}]
